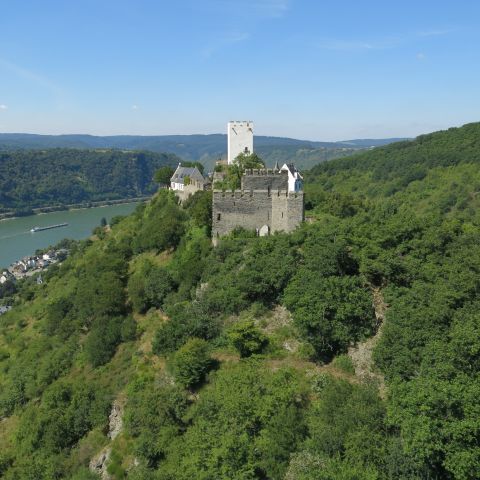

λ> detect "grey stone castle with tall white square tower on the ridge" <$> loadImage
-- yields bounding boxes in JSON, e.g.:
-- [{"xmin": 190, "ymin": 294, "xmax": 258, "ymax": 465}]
[{"xmin": 212, "ymin": 122, "xmax": 304, "ymax": 245}]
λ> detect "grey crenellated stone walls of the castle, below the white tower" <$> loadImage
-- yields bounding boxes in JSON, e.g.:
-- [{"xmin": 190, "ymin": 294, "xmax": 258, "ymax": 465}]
[{"xmin": 212, "ymin": 166, "xmax": 303, "ymax": 244}]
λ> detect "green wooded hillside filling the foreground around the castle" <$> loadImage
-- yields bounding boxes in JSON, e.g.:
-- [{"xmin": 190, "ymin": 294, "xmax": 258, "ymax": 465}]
[{"xmin": 0, "ymin": 124, "xmax": 480, "ymax": 480}]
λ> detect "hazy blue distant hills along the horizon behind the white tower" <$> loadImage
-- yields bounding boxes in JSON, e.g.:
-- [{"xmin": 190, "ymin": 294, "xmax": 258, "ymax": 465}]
[{"xmin": 0, "ymin": 133, "xmax": 408, "ymax": 170}]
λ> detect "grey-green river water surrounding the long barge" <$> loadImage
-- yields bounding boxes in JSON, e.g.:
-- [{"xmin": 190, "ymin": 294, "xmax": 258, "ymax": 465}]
[{"xmin": 0, "ymin": 203, "xmax": 138, "ymax": 268}]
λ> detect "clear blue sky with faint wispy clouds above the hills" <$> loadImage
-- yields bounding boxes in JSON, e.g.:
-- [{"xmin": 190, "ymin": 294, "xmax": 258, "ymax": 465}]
[{"xmin": 0, "ymin": 0, "xmax": 480, "ymax": 140}]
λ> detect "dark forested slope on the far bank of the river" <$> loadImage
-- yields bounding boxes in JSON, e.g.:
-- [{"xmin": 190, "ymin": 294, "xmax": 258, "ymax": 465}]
[{"xmin": 0, "ymin": 148, "xmax": 179, "ymax": 213}]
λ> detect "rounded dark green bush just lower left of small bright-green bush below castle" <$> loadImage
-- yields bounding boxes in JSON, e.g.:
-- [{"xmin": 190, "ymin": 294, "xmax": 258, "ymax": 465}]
[{"xmin": 170, "ymin": 338, "xmax": 213, "ymax": 388}]
